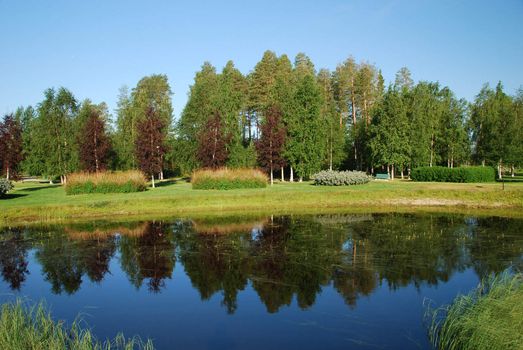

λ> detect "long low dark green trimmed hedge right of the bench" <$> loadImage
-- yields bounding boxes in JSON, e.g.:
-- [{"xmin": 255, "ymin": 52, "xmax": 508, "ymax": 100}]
[{"xmin": 410, "ymin": 166, "xmax": 496, "ymax": 182}]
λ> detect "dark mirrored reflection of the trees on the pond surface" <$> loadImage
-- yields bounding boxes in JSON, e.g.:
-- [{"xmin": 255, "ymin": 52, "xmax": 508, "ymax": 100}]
[{"xmin": 0, "ymin": 215, "xmax": 523, "ymax": 314}]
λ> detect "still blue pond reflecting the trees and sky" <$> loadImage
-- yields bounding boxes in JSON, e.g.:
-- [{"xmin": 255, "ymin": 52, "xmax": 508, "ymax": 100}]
[{"xmin": 0, "ymin": 214, "xmax": 523, "ymax": 350}]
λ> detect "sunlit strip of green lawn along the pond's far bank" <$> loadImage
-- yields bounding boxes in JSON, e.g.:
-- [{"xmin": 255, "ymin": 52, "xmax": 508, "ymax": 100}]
[{"xmin": 0, "ymin": 180, "xmax": 523, "ymax": 225}]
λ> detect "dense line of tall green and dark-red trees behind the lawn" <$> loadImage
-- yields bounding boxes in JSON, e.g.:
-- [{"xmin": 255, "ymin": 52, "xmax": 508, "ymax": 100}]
[{"xmin": 0, "ymin": 51, "xmax": 523, "ymax": 182}]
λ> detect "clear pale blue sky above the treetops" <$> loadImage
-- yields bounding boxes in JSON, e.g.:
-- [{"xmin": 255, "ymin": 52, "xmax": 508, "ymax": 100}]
[{"xmin": 0, "ymin": 0, "xmax": 523, "ymax": 118}]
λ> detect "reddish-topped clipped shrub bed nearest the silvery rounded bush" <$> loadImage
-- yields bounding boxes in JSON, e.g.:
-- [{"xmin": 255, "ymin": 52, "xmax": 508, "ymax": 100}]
[{"xmin": 191, "ymin": 168, "xmax": 267, "ymax": 190}]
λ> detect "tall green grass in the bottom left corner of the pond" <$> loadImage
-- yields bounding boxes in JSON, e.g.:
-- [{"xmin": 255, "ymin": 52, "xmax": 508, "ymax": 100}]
[{"xmin": 0, "ymin": 300, "xmax": 154, "ymax": 350}]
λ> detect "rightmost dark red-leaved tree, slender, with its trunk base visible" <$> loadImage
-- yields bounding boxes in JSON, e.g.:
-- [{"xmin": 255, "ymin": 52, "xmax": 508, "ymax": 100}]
[{"xmin": 255, "ymin": 106, "xmax": 287, "ymax": 185}]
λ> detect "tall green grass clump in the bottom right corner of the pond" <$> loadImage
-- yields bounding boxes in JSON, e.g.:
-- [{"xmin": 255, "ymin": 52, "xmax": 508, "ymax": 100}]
[{"xmin": 429, "ymin": 273, "xmax": 523, "ymax": 350}]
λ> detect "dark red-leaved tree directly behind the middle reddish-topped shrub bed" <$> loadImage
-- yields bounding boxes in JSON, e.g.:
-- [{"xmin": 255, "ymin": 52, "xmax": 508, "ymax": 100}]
[{"xmin": 197, "ymin": 112, "xmax": 231, "ymax": 169}]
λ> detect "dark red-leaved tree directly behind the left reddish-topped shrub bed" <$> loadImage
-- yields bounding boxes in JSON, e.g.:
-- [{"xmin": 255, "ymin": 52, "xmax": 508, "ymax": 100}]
[{"xmin": 78, "ymin": 110, "xmax": 111, "ymax": 172}]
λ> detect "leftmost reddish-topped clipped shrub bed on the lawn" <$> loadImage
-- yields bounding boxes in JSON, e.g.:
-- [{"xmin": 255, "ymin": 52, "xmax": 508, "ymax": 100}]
[{"xmin": 65, "ymin": 170, "xmax": 147, "ymax": 194}]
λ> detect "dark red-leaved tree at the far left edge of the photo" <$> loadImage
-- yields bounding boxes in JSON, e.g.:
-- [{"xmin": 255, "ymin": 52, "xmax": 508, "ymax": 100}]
[{"xmin": 0, "ymin": 114, "xmax": 23, "ymax": 180}]
